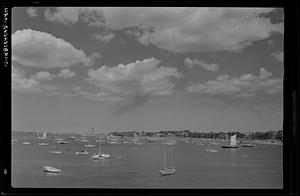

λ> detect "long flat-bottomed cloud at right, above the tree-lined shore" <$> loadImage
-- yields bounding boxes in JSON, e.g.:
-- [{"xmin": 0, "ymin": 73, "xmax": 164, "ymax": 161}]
[{"xmin": 187, "ymin": 68, "xmax": 283, "ymax": 97}]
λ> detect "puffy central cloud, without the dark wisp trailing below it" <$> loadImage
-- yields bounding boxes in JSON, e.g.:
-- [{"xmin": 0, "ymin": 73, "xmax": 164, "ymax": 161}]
[{"xmin": 87, "ymin": 58, "xmax": 182, "ymax": 99}]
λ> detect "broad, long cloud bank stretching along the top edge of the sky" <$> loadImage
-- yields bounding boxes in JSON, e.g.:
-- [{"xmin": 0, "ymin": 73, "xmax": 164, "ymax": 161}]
[{"xmin": 45, "ymin": 7, "xmax": 283, "ymax": 52}]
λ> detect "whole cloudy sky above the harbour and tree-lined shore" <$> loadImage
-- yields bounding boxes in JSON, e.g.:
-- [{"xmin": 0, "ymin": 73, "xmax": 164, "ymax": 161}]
[{"xmin": 12, "ymin": 7, "xmax": 284, "ymax": 133}]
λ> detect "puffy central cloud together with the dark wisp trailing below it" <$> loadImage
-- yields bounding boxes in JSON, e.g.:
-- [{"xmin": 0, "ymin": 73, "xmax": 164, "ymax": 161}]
[{"xmin": 83, "ymin": 58, "xmax": 182, "ymax": 112}]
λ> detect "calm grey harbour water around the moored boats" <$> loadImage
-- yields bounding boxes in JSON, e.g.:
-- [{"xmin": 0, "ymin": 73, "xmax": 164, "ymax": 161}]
[{"xmin": 12, "ymin": 133, "xmax": 283, "ymax": 188}]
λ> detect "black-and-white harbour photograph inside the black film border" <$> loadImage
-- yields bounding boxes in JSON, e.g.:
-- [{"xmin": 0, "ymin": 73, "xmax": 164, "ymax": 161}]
[{"xmin": 4, "ymin": 6, "xmax": 296, "ymax": 189}]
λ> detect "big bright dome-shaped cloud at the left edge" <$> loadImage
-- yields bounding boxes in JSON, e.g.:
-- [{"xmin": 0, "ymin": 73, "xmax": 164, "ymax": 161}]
[{"xmin": 12, "ymin": 29, "xmax": 88, "ymax": 69}]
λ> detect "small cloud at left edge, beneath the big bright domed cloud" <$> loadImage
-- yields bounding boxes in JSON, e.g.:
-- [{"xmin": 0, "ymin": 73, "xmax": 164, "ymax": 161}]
[{"xmin": 12, "ymin": 67, "xmax": 42, "ymax": 92}]
